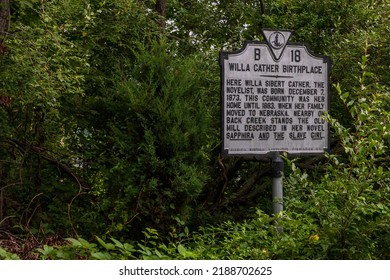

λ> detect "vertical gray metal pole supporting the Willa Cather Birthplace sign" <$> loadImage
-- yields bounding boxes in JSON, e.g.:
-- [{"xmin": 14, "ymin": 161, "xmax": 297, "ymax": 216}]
[{"xmin": 272, "ymin": 152, "xmax": 284, "ymax": 215}]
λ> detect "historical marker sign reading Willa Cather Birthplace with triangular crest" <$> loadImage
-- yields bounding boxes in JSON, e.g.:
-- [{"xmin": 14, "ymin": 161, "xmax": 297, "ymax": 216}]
[{"xmin": 220, "ymin": 30, "xmax": 330, "ymax": 156}]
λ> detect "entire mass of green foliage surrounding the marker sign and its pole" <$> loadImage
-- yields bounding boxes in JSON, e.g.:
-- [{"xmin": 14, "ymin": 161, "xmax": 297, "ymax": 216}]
[{"xmin": 0, "ymin": 0, "xmax": 390, "ymax": 259}]
